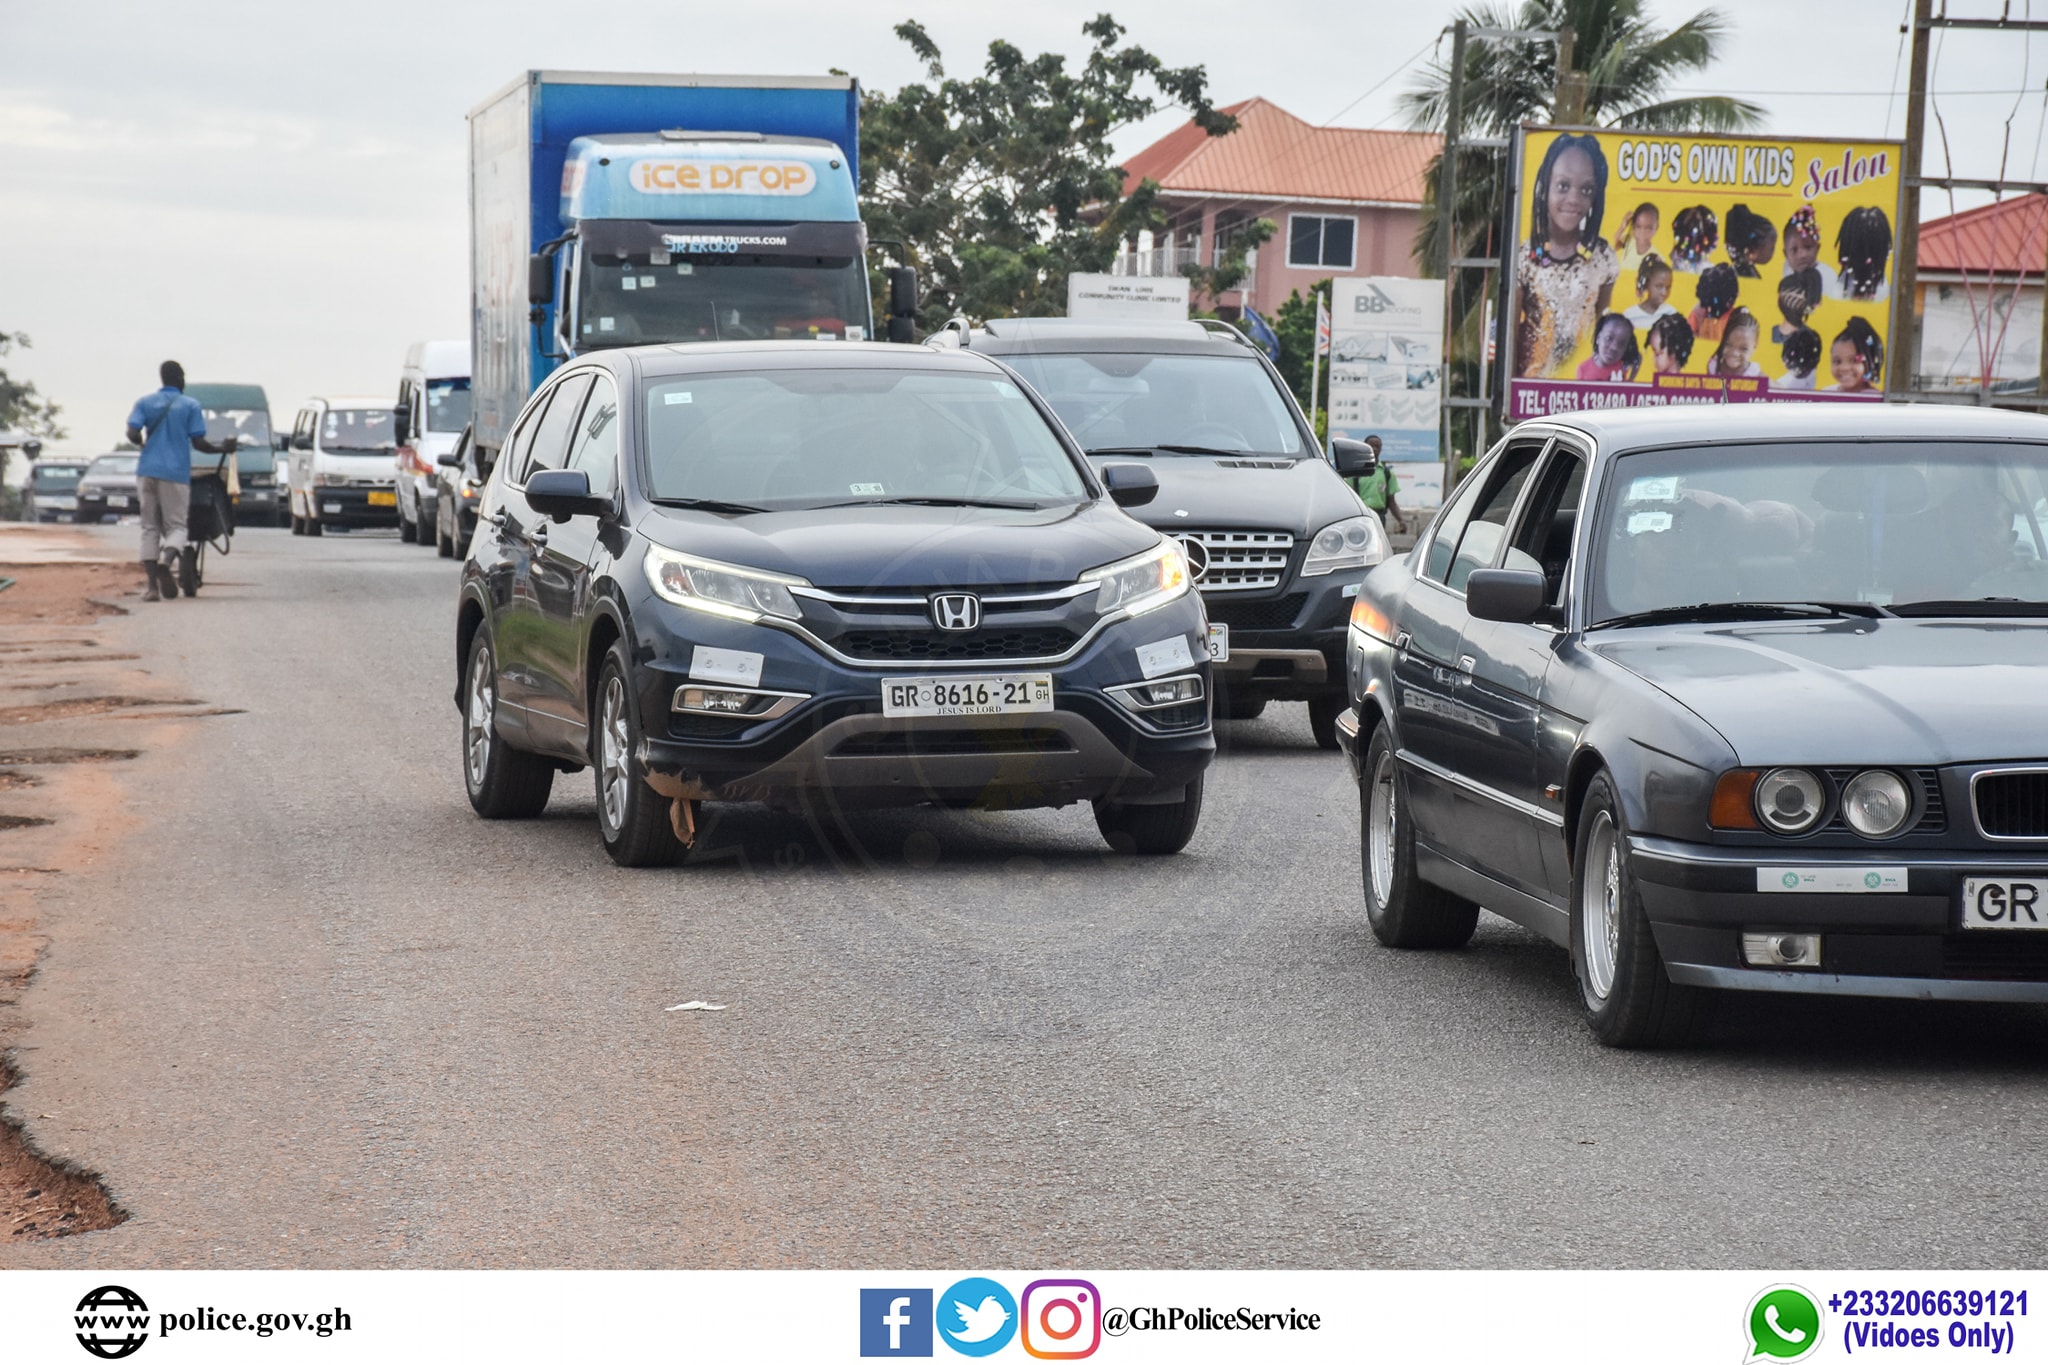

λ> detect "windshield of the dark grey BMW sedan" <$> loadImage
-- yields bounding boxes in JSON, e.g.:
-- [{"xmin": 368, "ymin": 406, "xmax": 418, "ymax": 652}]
[{"xmin": 1593, "ymin": 442, "xmax": 2048, "ymax": 622}]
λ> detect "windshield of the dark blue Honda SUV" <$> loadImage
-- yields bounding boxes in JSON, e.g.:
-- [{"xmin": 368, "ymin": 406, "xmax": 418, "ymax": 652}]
[{"xmin": 645, "ymin": 370, "xmax": 1087, "ymax": 512}]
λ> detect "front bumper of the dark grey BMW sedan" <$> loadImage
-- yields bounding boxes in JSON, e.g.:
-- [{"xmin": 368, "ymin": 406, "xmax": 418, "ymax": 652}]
[{"xmin": 1630, "ymin": 837, "xmax": 2048, "ymax": 1003}]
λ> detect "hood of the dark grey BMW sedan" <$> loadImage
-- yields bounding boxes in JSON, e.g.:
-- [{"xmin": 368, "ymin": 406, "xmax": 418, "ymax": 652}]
[{"xmin": 1585, "ymin": 620, "xmax": 2048, "ymax": 767}]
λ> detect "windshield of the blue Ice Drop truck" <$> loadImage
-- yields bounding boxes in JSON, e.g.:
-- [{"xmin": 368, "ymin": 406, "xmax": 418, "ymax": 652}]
[{"xmin": 575, "ymin": 256, "xmax": 868, "ymax": 350}]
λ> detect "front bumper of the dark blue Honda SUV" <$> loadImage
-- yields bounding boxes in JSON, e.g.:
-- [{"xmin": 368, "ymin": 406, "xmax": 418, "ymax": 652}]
[{"xmin": 635, "ymin": 598, "xmax": 1217, "ymax": 808}]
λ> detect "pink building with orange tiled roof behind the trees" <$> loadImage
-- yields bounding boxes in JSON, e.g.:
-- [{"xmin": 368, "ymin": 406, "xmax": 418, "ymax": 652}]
[{"xmin": 1116, "ymin": 98, "xmax": 1442, "ymax": 315}]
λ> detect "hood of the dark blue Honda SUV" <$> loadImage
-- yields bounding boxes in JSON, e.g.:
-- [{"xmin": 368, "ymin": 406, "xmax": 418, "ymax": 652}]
[{"xmin": 637, "ymin": 499, "xmax": 1159, "ymax": 591}]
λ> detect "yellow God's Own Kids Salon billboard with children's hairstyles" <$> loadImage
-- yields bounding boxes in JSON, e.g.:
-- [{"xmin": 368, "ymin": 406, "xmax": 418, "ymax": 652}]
[{"xmin": 1507, "ymin": 129, "xmax": 1903, "ymax": 422}]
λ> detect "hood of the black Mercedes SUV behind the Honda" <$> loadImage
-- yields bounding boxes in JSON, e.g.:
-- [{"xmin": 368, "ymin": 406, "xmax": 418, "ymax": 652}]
[{"xmin": 1087, "ymin": 454, "xmax": 1364, "ymax": 540}]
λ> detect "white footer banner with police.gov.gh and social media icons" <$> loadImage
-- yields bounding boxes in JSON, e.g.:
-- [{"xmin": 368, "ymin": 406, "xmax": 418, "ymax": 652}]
[{"xmin": 0, "ymin": 1271, "xmax": 2048, "ymax": 1365}]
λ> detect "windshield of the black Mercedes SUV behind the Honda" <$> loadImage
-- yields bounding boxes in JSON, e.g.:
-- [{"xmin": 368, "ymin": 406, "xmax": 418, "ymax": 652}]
[{"xmin": 1004, "ymin": 354, "xmax": 1305, "ymax": 456}]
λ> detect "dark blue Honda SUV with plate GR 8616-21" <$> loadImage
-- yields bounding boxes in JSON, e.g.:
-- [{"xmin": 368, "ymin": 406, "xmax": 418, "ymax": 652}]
[{"xmin": 455, "ymin": 342, "xmax": 1214, "ymax": 866}]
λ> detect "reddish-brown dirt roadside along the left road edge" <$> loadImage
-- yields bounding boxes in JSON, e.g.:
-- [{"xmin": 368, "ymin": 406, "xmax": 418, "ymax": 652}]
[{"xmin": 0, "ymin": 526, "xmax": 218, "ymax": 1242}]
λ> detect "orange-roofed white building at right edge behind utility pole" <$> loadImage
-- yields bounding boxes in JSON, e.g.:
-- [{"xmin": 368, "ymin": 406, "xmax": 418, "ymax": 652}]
[{"xmin": 1913, "ymin": 194, "xmax": 2048, "ymax": 393}]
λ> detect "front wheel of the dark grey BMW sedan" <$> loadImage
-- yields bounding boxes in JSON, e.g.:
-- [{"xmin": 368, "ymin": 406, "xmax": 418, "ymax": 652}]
[{"xmin": 1571, "ymin": 774, "xmax": 1706, "ymax": 1048}]
